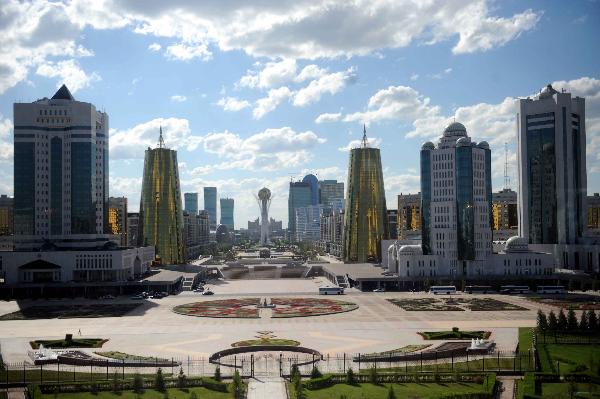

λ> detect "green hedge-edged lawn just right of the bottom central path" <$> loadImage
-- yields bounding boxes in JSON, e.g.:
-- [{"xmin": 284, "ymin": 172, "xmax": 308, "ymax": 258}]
[{"xmin": 290, "ymin": 383, "xmax": 491, "ymax": 399}]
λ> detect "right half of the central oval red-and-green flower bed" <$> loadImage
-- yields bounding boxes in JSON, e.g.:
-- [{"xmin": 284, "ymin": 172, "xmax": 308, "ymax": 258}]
[{"xmin": 271, "ymin": 298, "xmax": 358, "ymax": 318}]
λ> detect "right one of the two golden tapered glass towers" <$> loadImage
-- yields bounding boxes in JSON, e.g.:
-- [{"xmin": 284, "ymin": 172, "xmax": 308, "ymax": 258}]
[{"xmin": 343, "ymin": 127, "xmax": 388, "ymax": 262}]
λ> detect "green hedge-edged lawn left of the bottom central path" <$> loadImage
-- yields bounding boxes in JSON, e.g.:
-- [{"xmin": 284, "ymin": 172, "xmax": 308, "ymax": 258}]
[{"xmin": 33, "ymin": 387, "xmax": 231, "ymax": 399}]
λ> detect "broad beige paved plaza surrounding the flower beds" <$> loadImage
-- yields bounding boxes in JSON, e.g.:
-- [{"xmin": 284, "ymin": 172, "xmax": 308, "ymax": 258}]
[{"xmin": 0, "ymin": 278, "xmax": 564, "ymax": 362}]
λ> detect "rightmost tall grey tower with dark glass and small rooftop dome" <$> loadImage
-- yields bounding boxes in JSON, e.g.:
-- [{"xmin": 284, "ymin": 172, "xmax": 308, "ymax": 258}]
[{"xmin": 517, "ymin": 85, "xmax": 587, "ymax": 244}]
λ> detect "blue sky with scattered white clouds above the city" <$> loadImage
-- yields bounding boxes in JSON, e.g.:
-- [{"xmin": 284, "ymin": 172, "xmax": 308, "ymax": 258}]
[{"xmin": 0, "ymin": 0, "xmax": 600, "ymax": 228}]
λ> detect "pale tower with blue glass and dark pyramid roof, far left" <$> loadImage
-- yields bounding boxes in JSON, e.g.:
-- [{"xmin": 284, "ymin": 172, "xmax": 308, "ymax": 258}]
[{"xmin": 14, "ymin": 85, "xmax": 109, "ymax": 249}]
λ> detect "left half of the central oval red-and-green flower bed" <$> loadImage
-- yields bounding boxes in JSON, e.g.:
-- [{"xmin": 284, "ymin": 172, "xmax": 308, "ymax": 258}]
[{"xmin": 173, "ymin": 298, "xmax": 259, "ymax": 319}]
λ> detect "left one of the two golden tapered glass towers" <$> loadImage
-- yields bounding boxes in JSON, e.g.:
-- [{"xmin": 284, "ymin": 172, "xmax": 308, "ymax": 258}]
[{"xmin": 138, "ymin": 128, "xmax": 186, "ymax": 264}]
